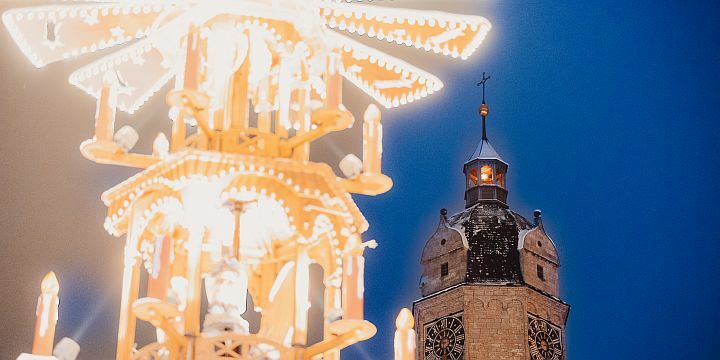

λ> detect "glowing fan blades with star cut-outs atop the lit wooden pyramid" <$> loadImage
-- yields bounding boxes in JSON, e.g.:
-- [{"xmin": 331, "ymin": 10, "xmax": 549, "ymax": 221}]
[{"xmin": 3, "ymin": 0, "xmax": 491, "ymax": 112}]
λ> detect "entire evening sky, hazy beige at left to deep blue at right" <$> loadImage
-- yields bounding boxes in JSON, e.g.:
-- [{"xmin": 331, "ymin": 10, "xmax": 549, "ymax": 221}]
[{"xmin": 0, "ymin": 0, "xmax": 720, "ymax": 360}]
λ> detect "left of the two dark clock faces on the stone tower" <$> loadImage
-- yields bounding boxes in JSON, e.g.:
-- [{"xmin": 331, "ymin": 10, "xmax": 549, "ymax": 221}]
[{"xmin": 425, "ymin": 313, "xmax": 465, "ymax": 360}]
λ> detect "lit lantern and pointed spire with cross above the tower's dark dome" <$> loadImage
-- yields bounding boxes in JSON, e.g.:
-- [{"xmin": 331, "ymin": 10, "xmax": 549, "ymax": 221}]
[{"xmin": 463, "ymin": 73, "xmax": 508, "ymax": 208}]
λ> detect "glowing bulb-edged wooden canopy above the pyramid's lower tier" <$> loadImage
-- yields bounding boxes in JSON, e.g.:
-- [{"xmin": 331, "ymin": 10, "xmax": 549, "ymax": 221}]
[{"xmin": 102, "ymin": 149, "xmax": 372, "ymax": 236}]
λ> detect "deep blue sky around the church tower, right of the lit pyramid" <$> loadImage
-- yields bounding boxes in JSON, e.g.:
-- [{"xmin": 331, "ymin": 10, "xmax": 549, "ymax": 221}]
[{"xmin": 345, "ymin": 1, "xmax": 720, "ymax": 360}]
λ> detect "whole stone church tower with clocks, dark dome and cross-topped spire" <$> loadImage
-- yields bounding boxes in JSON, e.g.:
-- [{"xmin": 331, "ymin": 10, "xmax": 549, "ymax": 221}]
[{"xmin": 413, "ymin": 74, "xmax": 570, "ymax": 360}]
